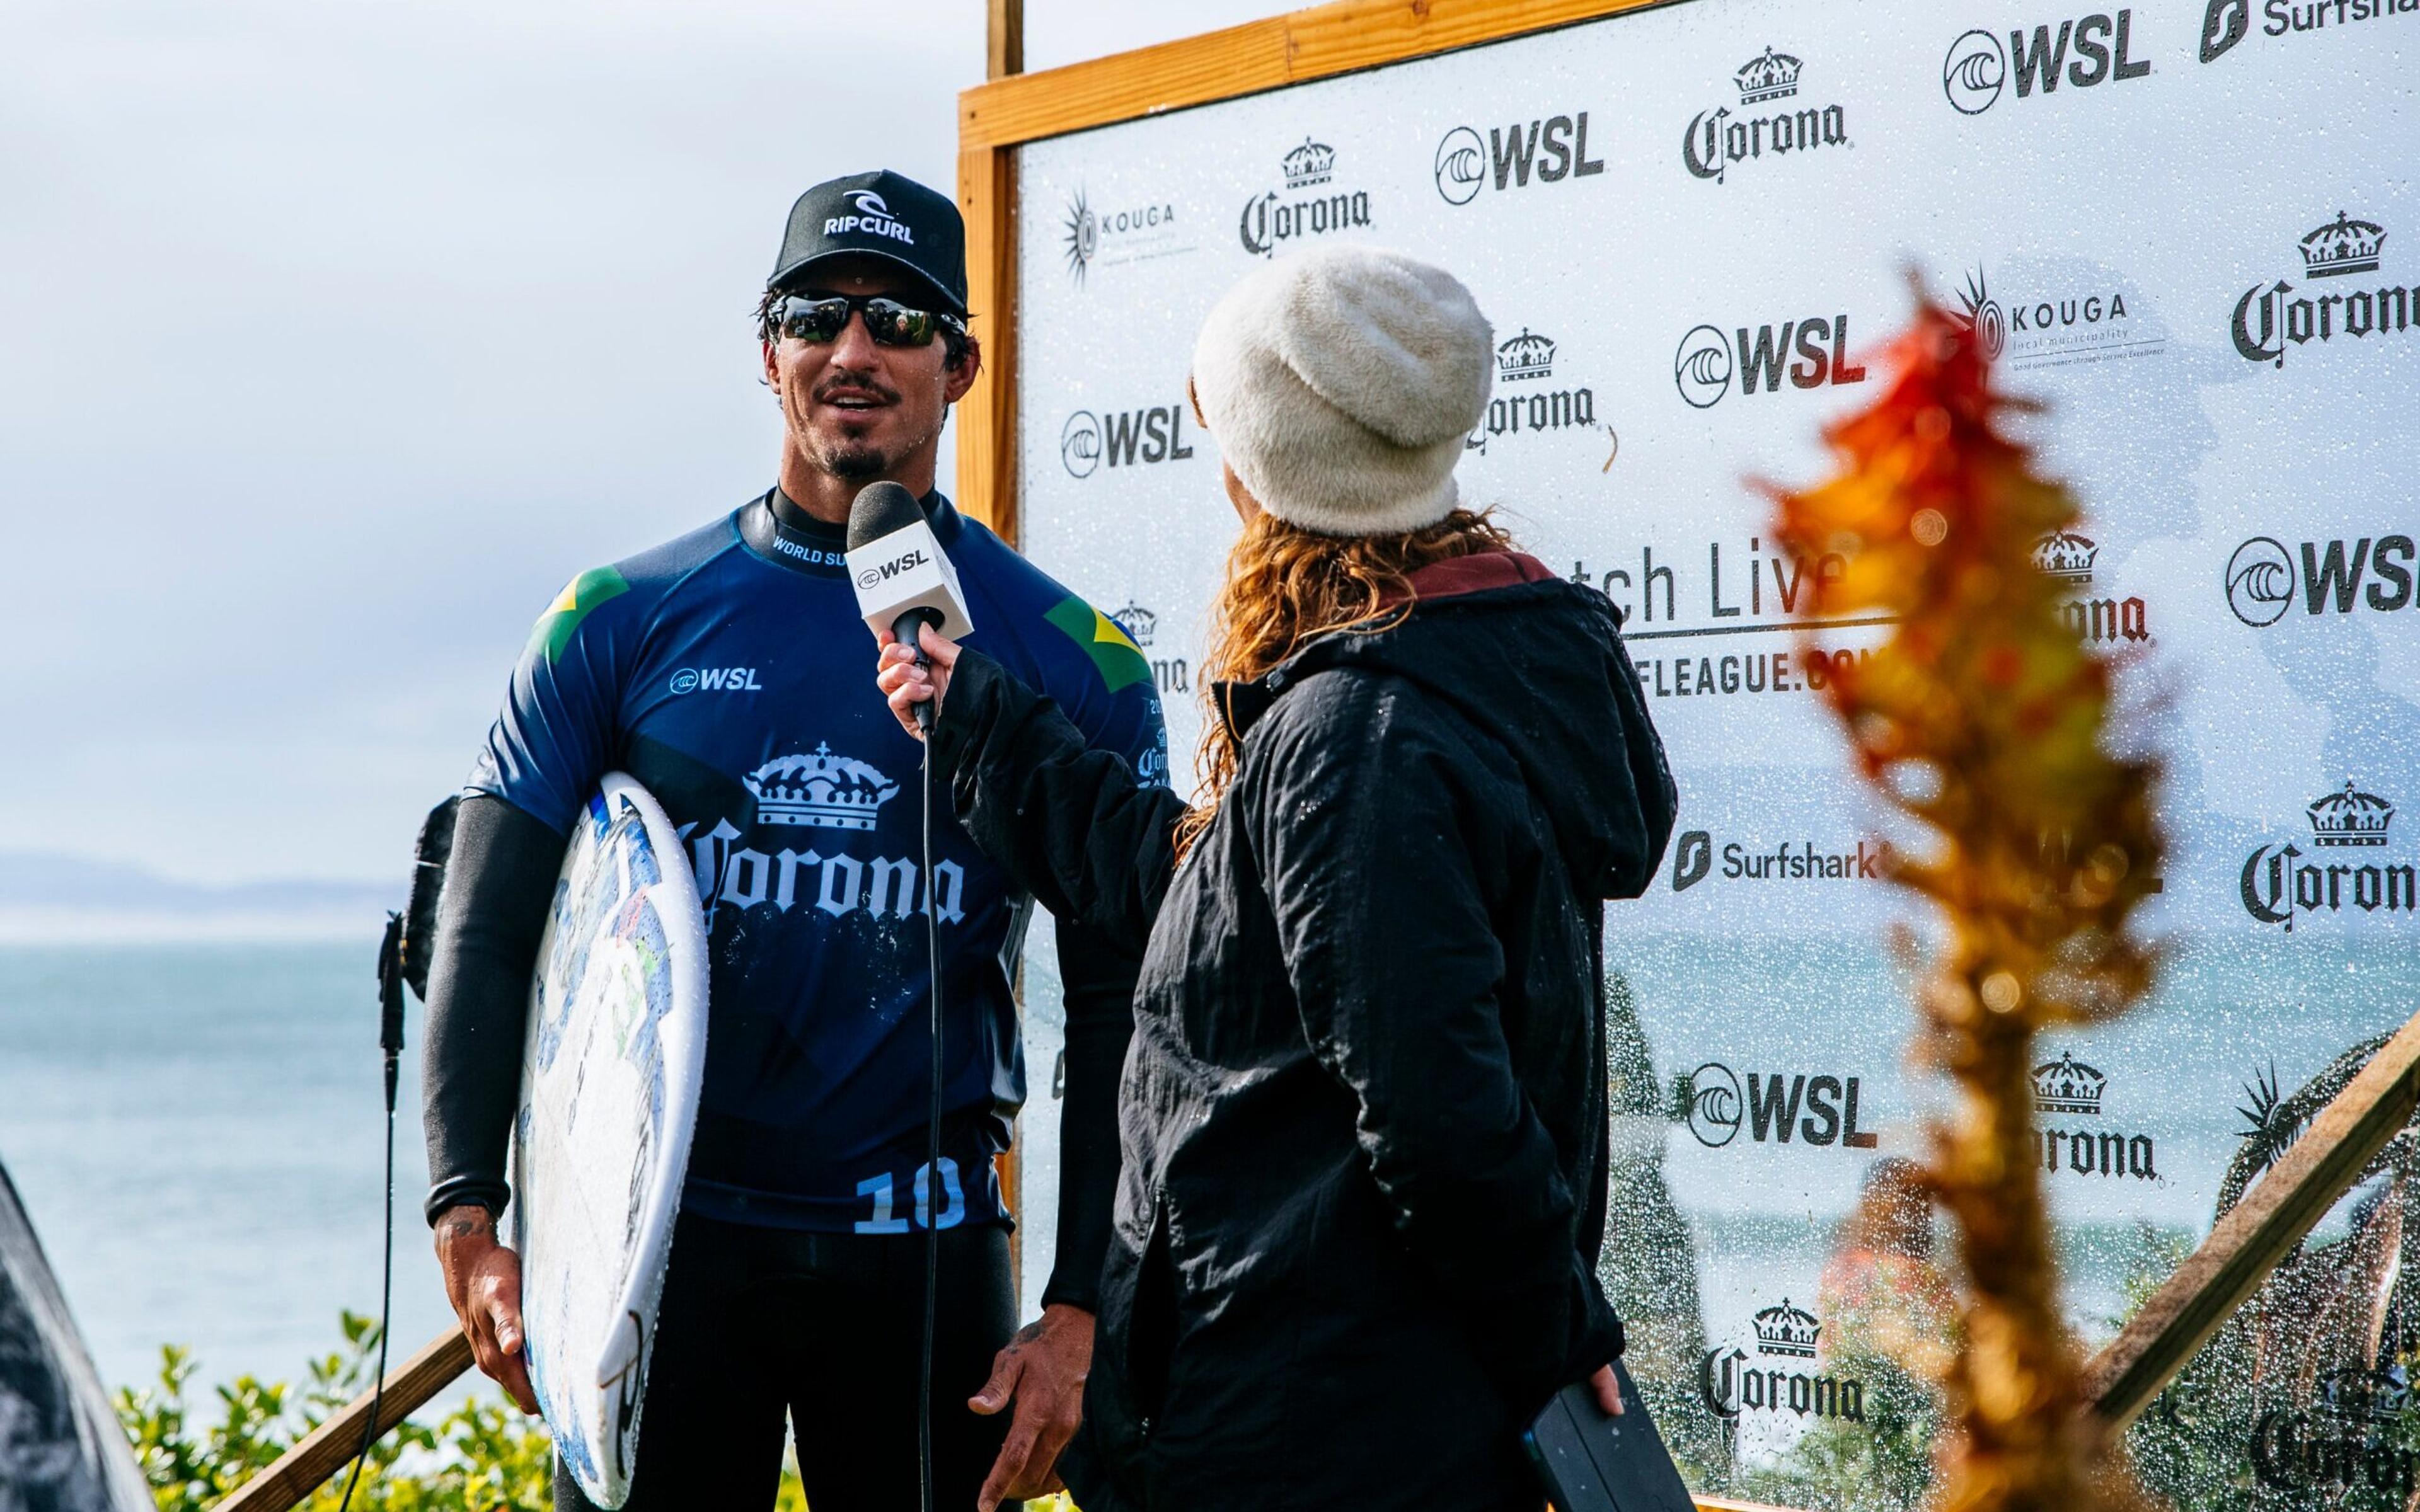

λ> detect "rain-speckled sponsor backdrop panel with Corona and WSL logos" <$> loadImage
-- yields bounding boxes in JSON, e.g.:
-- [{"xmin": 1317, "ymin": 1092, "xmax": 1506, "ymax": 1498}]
[{"xmin": 997, "ymin": 0, "xmax": 2420, "ymax": 1504}]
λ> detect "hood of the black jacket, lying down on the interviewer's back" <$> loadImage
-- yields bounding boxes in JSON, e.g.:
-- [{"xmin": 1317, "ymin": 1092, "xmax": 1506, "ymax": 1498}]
[{"xmin": 1219, "ymin": 552, "xmax": 1680, "ymax": 898}]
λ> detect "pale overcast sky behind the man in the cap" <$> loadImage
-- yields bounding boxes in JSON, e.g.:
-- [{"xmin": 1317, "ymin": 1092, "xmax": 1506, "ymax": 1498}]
[{"xmin": 0, "ymin": 0, "xmax": 1285, "ymax": 881}]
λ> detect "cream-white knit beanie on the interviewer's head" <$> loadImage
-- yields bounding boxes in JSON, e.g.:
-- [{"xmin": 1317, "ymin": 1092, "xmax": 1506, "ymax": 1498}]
[{"xmin": 1193, "ymin": 247, "xmax": 1495, "ymax": 535}]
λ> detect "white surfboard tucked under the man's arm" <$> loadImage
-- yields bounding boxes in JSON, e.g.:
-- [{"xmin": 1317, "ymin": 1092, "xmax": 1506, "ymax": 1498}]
[{"xmin": 513, "ymin": 772, "xmax": 706, "ymax": 1507}]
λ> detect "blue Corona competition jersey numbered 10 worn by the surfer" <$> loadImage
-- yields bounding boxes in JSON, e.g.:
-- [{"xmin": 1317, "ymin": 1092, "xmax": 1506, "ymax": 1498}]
[{"xmin": 470, "ymin": 493, "xmax": 1167, "ymax": 1234}]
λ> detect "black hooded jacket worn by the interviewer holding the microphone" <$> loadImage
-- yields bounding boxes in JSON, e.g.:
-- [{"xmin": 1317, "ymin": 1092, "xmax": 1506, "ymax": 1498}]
[{"xmin": 914, "ymin": 554, "xmax": 1674, "ymax": 1512}]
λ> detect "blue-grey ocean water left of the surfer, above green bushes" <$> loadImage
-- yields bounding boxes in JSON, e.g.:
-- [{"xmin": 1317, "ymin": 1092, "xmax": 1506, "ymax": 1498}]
[{"xmin": 0, "ymin": 936, "xmax": 452, "ymax": 1386}]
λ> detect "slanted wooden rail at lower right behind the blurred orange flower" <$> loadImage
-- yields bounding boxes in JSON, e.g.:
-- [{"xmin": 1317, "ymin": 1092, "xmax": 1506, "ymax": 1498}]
[{"xmin": 2083, "ymin": 1016, "xmax": 2420, "ymax": 1429}]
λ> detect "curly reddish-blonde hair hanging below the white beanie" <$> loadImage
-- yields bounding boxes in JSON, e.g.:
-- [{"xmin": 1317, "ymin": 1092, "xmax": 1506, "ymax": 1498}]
[{"xmin": 1176, "ymin": 508, "xmax": 1512, "ymax": 861}]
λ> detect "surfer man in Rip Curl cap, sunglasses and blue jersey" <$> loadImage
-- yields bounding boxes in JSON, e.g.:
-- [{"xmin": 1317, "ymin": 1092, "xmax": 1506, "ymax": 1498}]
[{"xmin": 424, "ymin": 172, "xmax": 1167, "ymax": 1512}]
